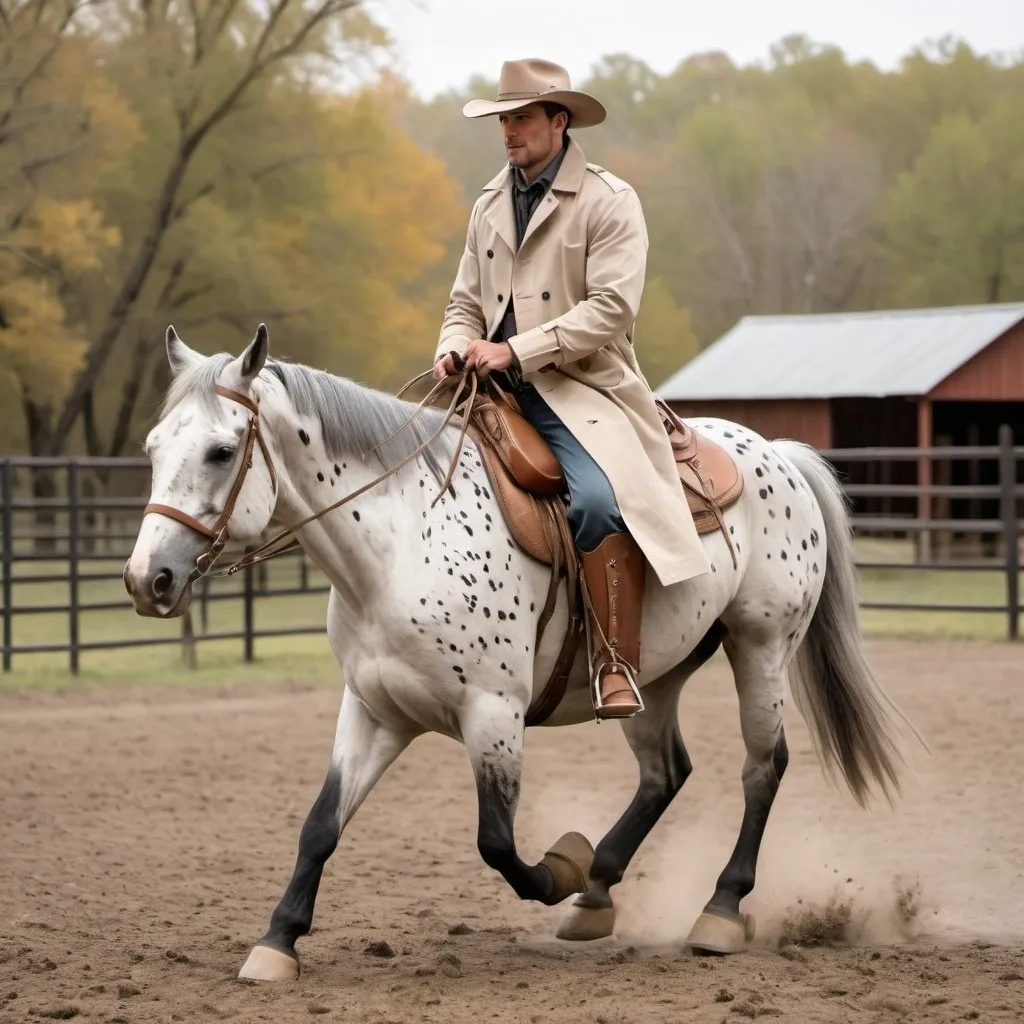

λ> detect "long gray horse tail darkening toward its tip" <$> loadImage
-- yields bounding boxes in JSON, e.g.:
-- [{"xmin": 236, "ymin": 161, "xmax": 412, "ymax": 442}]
[{"xmin": 776, "ymin": 441, "xmax": 920, "ymax": 806}]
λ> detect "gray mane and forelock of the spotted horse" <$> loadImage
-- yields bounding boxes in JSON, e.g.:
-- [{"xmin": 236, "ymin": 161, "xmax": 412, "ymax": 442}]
[{"xmin": 161, "ymin": 352, "xmax": 456, "ymax": 482}]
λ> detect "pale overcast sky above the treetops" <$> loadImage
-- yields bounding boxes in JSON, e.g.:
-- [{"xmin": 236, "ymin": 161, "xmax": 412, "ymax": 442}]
[{"xmin": 368, "ymin": 0, "xmax": 1024, "ymax": 97}]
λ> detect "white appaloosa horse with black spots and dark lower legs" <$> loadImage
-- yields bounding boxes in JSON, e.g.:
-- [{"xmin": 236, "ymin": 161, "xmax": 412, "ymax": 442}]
[{"xmin": 124, "ymin": 325, "xmax": 917, "ymax": 980}]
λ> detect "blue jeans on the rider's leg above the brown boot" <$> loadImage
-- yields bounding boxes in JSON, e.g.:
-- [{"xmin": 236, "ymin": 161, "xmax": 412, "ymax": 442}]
[{"xmin": 513, "ymin": 383, "xmax": 627, "ymax": 551}]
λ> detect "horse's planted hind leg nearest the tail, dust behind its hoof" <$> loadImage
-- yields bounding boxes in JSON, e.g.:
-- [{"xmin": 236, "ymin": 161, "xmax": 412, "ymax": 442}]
[{"xmin": 686, "ymin": 634, "xmax": 790, "ymax": 953}]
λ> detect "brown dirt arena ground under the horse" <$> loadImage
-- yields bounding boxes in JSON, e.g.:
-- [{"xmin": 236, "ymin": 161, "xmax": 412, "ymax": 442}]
[{"xmin": 0, "ymin": 641, "xmax": 1024, "ymax": 1024}]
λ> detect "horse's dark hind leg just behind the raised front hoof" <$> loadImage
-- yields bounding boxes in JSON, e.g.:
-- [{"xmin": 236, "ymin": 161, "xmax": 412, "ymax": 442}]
[{"xmin": 556, "ymin": 622, "xmax": 725, "ymax": 942}]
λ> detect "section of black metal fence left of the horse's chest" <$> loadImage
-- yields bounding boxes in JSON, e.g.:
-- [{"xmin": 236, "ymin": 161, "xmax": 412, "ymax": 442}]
[{"xmin": 0, "ymin": 458, "xmax": 330, "ymax": 675}]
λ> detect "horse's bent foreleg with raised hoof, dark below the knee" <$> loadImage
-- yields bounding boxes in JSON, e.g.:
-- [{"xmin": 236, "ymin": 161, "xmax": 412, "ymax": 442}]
[{"xmin": 462, "ymin": 695, "xmax": 594, "ymax": 905}]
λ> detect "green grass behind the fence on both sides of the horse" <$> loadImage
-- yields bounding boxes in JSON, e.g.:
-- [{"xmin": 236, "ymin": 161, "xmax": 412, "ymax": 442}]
[{"xmin": 0, "ymin": 539, "xmax": 1007, "ymax": 690}]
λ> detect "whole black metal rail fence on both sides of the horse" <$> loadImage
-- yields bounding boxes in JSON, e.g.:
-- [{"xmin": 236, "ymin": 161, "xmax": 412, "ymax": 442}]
[{"xmin": 0, "ymin": 427, "xmax": 1024, "ymax": 674}]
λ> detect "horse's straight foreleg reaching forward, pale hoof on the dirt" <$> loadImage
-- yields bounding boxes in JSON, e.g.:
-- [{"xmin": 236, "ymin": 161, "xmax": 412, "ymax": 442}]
[{"xmin": 239, "ymin": 688, "xmax": 413, "ymax": 981}]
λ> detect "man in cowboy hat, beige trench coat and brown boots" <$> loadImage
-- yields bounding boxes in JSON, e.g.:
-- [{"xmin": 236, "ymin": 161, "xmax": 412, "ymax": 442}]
[{"xmin": 434, "ymin": 59, "xmax": 710, "ymax": 718}]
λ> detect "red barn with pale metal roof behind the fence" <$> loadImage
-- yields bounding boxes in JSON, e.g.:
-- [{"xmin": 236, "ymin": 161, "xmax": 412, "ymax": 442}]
[{"xmin": 656, "ymin": 303, "xmax": 1024, "ymax": 544}]
